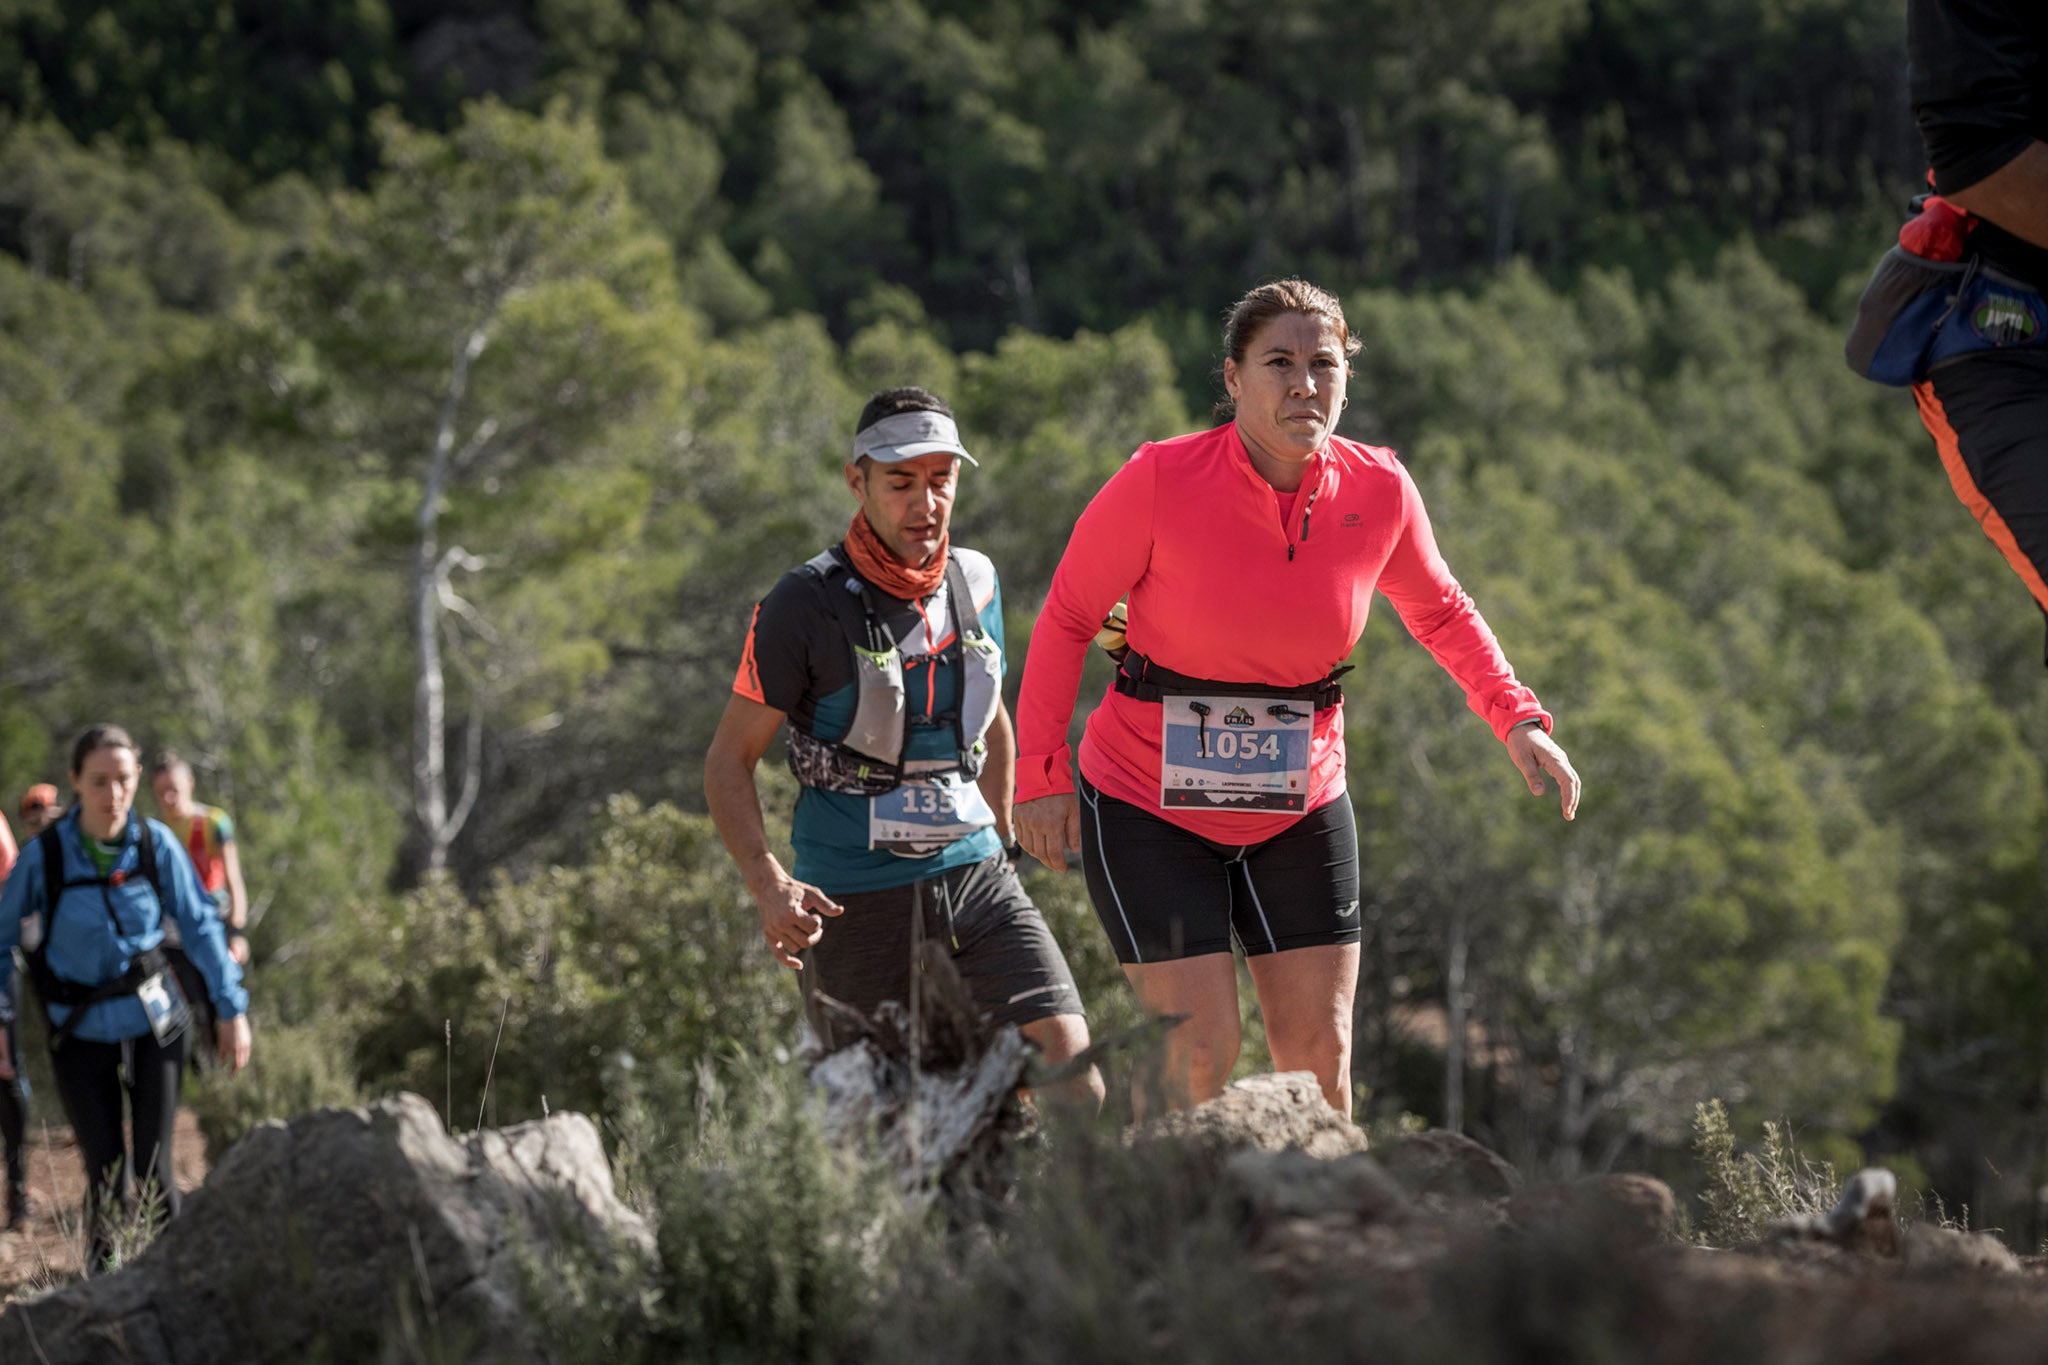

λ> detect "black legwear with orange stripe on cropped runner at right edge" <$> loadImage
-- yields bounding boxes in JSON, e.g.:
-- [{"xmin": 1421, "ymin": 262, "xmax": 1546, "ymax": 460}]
[{"xmin": 1913, "ymin": 350, "xmax": 2048, "ymax": 654}]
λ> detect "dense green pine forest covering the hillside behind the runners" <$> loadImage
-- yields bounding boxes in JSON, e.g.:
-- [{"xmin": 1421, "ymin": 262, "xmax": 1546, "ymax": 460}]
[{"xmin": 0, "ymin": 0, "xmax": 2048, "ymax": 1246}]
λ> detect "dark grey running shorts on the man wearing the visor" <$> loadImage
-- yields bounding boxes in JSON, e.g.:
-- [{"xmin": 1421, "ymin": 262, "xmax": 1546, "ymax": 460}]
[{"xmin": 805, "ymin": 853, "xmax": 1083, "ymax": 1025}]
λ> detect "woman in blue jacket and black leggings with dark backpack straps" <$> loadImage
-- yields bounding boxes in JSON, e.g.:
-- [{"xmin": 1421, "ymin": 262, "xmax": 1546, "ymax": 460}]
[{"xmin": 0, "ymin": 724, "xmax": 250, "ymax": 1271}]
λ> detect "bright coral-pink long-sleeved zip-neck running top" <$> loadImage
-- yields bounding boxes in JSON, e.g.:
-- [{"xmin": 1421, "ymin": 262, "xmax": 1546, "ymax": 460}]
[{"xmin": 1016, "ymin": 424, "xmax": 1550, "ymax": 843}]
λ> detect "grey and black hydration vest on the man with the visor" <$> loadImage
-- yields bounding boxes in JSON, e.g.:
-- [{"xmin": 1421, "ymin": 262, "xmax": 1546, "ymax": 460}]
[{"xmin": 788, "ymin": 546, "xmax": 1004, "ymax": 796}]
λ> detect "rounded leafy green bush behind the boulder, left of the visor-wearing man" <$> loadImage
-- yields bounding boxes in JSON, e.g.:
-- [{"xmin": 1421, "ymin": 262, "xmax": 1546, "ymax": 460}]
[{"xmin": 336, "ymin": 796, "xmax": 799, "ymax": 1126}]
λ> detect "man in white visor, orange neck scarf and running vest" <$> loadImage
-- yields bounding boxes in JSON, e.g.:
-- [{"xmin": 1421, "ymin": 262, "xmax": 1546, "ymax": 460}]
[{"xmin": 705, "ymin": 389, "xmax": 1102, "ymax": 1105}]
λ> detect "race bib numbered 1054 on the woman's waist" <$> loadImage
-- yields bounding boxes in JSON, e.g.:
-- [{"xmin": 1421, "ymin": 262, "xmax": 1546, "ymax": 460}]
[{"xmin": 1159, "ymin": 696, "xmax": 1315, "ymax": 810}]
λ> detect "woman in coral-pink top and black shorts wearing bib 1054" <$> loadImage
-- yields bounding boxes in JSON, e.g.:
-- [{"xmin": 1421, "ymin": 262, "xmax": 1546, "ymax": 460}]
[{"xmin": 1016, "ymin": 280, "xmax": 1579, "ymax": 1113}]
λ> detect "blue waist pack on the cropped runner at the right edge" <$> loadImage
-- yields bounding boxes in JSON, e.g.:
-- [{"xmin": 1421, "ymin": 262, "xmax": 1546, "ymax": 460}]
[{"xmin": 1843, "ymin": 246, "xmax": 2048, "ymax": 387}]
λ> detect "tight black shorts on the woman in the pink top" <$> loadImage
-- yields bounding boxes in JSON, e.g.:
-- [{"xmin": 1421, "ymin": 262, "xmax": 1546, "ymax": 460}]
[{"xmin": 1075, "ymin": 778, "xmax": 1358, "ymax": 964}]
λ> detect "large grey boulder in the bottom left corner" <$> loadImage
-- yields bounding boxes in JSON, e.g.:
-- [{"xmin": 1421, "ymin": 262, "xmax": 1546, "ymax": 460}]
[{"xmin": 0, "ymin": 1095, "xmax": 653, "ymax": 1365}]
